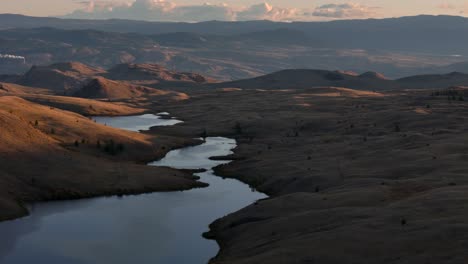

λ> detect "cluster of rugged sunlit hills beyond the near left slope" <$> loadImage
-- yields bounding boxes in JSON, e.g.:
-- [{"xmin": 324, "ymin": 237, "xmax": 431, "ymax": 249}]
[{"xmin": 8, "ymin": 62, "xmax": 215, "ymax": 94}]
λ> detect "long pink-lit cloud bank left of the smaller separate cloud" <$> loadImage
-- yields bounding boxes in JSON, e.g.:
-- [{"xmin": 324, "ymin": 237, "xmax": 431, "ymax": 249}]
[{"xmin": 65, "ymin": 0, "xmax": 311, "ymax": 22}]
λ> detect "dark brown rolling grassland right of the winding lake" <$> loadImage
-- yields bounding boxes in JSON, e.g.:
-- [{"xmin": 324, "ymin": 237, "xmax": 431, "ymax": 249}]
[{"xmin": 153, "ymin": 88, "xmax": 468, "ymax": 263}]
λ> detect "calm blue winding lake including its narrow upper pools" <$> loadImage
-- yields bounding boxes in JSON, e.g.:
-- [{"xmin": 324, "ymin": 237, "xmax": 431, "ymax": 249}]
[{"xmin": 0, "ymin": 116, "xmax": 266, "ymax": 264}]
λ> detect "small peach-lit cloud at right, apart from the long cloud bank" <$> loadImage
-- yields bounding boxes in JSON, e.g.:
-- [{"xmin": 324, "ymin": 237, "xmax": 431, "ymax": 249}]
[{"xmin": 312, "ymin": 3, "xmax": 378, "ymax": 18}]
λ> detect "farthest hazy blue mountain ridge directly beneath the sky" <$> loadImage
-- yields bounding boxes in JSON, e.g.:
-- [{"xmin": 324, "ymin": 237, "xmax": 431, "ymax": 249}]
[{"xmin": 0, "ymin": 14, "xmax": 468, "ymax": 55}]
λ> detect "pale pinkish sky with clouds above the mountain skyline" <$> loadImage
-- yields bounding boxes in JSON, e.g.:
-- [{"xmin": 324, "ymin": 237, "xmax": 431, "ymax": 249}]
[{"xmin": 0, "ymin": 0, "xmax": 468, "ymax": 22}]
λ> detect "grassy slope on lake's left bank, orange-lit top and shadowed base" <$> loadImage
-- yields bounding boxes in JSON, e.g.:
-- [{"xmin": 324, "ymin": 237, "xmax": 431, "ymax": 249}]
[{"xmin": 0, "ymin": 96, "xmax": 202, "ymax": 220}]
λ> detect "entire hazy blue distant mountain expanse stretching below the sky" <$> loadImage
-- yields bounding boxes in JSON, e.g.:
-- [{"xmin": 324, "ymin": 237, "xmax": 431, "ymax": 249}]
[{"xmin": 0, "ymin": 14, "xmax": 468, "ymax": 81}]
